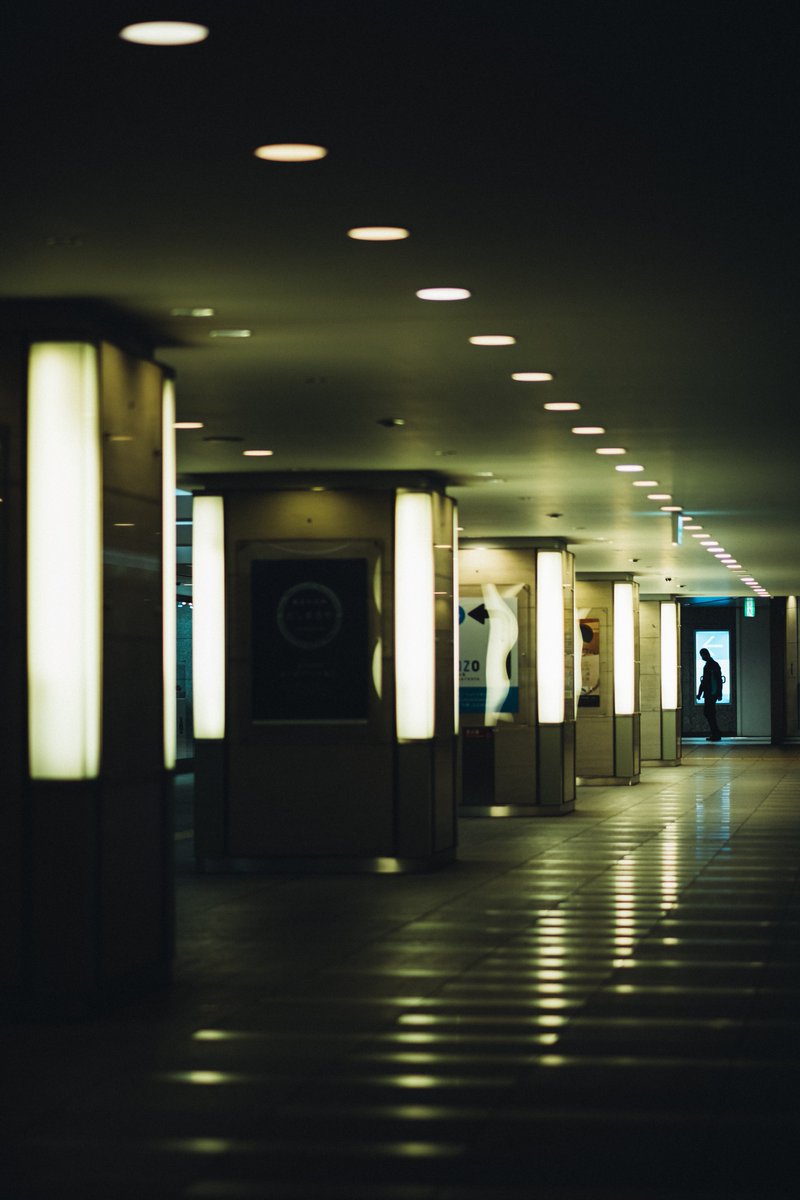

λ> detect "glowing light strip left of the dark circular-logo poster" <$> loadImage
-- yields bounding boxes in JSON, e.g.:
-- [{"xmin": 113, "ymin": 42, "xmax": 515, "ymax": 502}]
[{"xmin": 192, "ymin": 496, "xmax": 225, "ymax": 738}]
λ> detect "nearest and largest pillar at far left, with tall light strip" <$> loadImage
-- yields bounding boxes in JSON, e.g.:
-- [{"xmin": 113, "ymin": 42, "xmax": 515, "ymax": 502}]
[{"xmin": 14, "ymin": 333, "xmax": 175, "ymax": 1012}]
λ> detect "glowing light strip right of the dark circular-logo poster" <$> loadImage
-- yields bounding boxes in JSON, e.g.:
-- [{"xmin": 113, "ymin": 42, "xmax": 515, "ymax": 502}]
[{"xmin": 395, "ymin": 490, "xmax": 435, "ymax": 742}]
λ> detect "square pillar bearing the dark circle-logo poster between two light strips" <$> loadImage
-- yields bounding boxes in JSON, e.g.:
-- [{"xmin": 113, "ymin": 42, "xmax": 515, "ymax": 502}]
[{"xmin": 185, "ymin": 473, "xmax": 459, "ymax": 872}]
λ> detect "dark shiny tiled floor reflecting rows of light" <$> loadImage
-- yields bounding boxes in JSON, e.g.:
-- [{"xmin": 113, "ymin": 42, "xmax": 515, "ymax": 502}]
[{"xmin": 0, "ymin": 743, "xmax": 800, "ymax": 1200}]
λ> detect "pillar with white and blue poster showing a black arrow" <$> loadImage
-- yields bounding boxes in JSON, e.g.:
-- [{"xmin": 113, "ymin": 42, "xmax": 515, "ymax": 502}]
[{"xmin": 458, "ymin": 538, "xmax": 576, "ymax": 816}]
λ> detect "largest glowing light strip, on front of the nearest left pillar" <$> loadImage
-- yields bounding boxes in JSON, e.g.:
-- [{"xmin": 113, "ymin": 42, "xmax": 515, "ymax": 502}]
[{"xmin": 28, "ymin": 342, "xmax": 103, "ymax": 780}]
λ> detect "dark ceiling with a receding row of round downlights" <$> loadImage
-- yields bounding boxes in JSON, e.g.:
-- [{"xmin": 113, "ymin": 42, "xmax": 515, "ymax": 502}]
[{"xmin": 0, "ymin": 0, "xmax": 800, "ymax": 596}]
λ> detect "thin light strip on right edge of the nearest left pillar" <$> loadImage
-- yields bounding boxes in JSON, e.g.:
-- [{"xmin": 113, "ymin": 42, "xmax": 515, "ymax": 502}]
[{"xmin": 161, "ymin": 379, "xmax": 178, "ymax": 770}]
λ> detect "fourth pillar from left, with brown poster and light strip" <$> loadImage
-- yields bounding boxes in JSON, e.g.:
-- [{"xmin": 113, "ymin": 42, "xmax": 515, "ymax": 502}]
[{"xmin": 577, "ymin": 572, "xmax": 640, "ymax": 784}]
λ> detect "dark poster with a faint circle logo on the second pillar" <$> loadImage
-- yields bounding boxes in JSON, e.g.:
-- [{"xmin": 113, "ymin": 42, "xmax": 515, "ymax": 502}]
[{"xmin": 251, "ymin": 558, "xmax": 369, "ymax": 721}]
